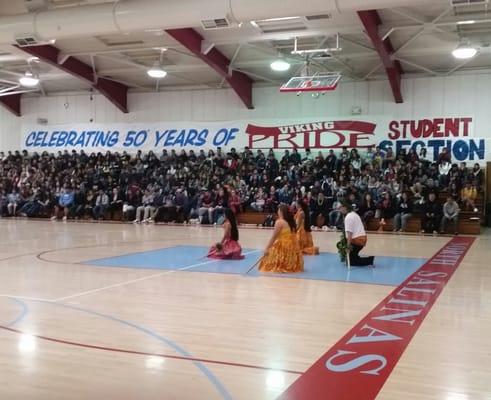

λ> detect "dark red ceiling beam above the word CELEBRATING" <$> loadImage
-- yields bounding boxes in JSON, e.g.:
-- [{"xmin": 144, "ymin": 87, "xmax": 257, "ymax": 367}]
[{"xmin": 18, "ymin": 45, "xmax": 128, "ymax": 113}]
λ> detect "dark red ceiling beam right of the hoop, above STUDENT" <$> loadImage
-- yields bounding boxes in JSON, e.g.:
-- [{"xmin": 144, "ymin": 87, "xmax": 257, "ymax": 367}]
[{"xmin": 358, "ymin": 10, "xmax": 404, "ymax": 103}]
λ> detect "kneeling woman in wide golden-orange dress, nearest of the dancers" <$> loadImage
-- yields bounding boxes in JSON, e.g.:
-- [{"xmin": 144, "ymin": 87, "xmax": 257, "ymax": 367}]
[{"xmin": 259, "ymin": 204, "xmax": 303, "ymax": 273}]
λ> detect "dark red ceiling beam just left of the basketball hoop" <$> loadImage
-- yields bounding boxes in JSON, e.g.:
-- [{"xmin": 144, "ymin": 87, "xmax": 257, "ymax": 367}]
[{"xmin": 166, "ymin": 28, "xmax": 254, "ymax": 109}]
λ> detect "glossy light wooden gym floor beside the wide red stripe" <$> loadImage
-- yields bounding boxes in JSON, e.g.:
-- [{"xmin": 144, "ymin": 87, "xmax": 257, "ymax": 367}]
[{"xmin": 0, "ymin": 220, "xmax": 491, "ymax": 400}]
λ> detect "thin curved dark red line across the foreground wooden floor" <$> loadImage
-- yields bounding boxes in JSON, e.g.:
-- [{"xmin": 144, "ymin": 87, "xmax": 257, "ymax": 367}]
[{"xmin": 0, "ymin": 325, "xmax": 303, "ymax": 375}]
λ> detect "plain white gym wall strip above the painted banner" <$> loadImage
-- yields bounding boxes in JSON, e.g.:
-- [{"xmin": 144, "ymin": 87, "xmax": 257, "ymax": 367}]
[{"xmin": 0, "ymin": 74, "xmax": 491, "ymax": 154}]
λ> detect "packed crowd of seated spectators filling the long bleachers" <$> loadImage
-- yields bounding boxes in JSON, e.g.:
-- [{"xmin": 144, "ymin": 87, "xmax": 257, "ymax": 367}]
[{"xmin": 0, "ymin": 148, "xmax": 484, "ymax": 232}]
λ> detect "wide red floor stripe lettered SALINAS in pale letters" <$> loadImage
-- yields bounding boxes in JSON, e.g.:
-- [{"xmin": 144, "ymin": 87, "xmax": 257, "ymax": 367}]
[{"xmin": 278, "ymin": 237, "xmax": 475, "ymax": 400}]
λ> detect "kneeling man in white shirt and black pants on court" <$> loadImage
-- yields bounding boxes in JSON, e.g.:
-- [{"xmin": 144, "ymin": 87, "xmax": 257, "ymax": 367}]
[{"xmin": 340, "ymin": 203, "xmax": 374, "ymax": 267}]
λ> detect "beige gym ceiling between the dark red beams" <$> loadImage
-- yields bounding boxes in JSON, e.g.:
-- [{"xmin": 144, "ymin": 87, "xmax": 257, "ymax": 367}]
[{"xmin": 0, "ymin": 0, "xmax": 491, "ymax": 96}]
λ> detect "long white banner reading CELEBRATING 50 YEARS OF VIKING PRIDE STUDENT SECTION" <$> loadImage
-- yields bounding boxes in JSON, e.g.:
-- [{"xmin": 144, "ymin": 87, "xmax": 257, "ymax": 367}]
[{"xmin": 22, "ymin": 117, "xmax": 491, "ymax": 162}]
